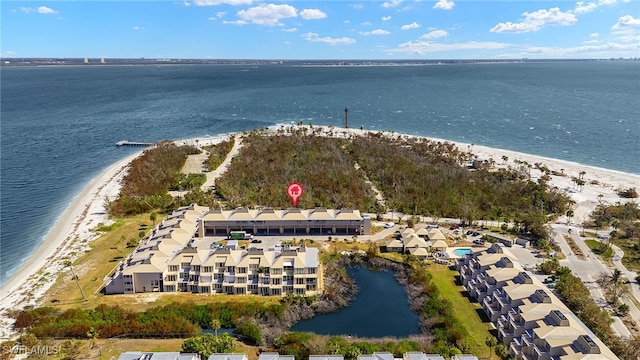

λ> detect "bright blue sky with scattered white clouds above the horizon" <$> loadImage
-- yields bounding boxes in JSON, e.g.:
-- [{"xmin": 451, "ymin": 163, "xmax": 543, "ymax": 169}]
[{"xmin": 0, "ymin": 0, "xmax": 640, "ymax": 60}]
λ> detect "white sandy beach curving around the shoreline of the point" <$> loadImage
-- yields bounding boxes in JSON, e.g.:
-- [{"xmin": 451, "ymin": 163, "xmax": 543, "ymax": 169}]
[{"xmin": 0, "ymin": 125, "xmax": 640, "ymax": 339}]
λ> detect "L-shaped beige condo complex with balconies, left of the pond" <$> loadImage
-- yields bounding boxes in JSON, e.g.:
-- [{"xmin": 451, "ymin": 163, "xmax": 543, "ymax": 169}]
[{"xmin": 105, "ymin": 205, "xmax": 322, "ymax": 296}]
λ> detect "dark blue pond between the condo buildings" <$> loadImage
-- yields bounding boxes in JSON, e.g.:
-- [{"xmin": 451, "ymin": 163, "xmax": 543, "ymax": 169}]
[{"xmin": 291, "ymin": 267, "xmax": 420, "ymax": 337}]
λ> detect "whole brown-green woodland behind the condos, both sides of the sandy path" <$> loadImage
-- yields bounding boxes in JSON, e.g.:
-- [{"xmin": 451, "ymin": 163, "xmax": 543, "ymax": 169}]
[{"xmin": 217, "ymin": 127, "xmax": 569, "ymax": 237}]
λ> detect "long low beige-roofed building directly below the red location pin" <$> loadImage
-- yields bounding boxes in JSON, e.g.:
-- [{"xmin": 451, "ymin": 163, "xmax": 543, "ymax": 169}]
[{"xmin": 200, "ymin": 207, "xmax": 371, "ymax": 236}]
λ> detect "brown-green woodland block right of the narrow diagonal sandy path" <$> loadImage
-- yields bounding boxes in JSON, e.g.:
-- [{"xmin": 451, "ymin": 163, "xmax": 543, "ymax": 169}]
[{"xmin": 349, "ymin": 133, "xmax": 569, "ymax": 234}]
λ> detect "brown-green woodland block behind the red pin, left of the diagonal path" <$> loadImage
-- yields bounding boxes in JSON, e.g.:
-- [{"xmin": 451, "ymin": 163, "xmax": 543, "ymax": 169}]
[{"xmin": 216, "ymin": 128, "xmax": 376, "ymax": 211}]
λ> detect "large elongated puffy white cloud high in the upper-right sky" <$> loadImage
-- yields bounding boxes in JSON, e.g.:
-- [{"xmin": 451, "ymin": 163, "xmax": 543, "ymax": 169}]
[{"xmin": 490, "ymin": 7, "xmax": 578, "ymax": 33}]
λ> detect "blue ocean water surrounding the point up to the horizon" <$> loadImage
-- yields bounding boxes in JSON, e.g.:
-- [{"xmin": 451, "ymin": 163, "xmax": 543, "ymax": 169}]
[{"xmin": 0, "ymin": 62, "xmax": 640, "ymax": 284}]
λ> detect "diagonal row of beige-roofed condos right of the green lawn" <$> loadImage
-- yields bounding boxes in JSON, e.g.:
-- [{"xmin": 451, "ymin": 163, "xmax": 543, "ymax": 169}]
[{"xmin": 457, "ymin": 243, "xmax": 617, "ymax": 360}]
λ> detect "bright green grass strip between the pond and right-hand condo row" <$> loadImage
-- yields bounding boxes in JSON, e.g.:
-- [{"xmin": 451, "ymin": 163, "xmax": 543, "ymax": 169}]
[{"xmin": 428, "ymin": 264, "xmax": 492, "ymax": 358}]
